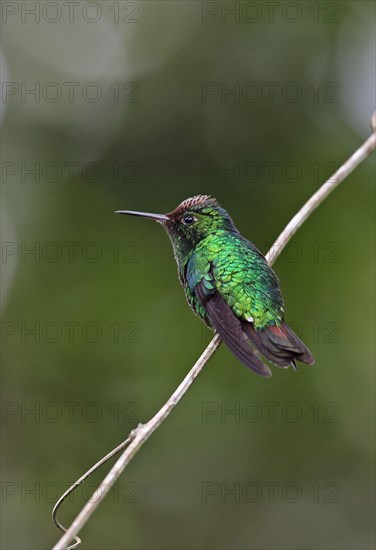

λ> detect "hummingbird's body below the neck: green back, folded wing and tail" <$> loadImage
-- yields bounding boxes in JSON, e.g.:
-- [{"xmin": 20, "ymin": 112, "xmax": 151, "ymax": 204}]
[{"xmin": 186, "ymin": 246, "xmax": 314, "ymax": 376}]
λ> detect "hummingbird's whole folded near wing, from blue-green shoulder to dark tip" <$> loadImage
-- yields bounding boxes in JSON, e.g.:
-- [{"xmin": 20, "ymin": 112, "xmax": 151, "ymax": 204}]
[{"xmin": 186, "ymin": 255, "xmax": 272, "ymax": 376}]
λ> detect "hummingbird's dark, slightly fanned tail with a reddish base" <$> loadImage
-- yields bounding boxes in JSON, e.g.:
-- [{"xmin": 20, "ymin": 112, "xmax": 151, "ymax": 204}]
[{"xmin": 242, "ymin": 322, "xmax": 315, "ymax": 369}]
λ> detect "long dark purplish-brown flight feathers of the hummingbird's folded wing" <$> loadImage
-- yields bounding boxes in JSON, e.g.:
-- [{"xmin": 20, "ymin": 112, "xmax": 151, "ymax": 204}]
[{"xmin": 194, "ymin": 281, "xmax": 272, "ymax": 376}]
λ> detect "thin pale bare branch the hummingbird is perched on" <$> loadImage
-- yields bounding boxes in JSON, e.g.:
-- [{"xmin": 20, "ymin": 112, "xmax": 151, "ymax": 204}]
[{"xmin": 53, "ymin": 113, "xmax": 376, "ymax": 550}]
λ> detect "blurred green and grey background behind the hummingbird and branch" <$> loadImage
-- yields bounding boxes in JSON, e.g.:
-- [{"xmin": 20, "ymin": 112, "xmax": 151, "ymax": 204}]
[{"xmin": 1, "ymin": 0, "xmax": 375, "ymax": 550}]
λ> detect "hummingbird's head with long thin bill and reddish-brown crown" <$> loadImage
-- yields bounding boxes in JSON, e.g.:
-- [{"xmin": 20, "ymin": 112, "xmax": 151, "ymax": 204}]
[{"xmin": 117, "ymin": 195, "xmax": 236, "ymax": 256}]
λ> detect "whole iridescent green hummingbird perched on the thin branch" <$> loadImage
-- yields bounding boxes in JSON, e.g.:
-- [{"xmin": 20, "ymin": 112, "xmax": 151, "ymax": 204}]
[{"xmin": 115, "ymin": 195, "xmax": 314, "ymax": 376}]
